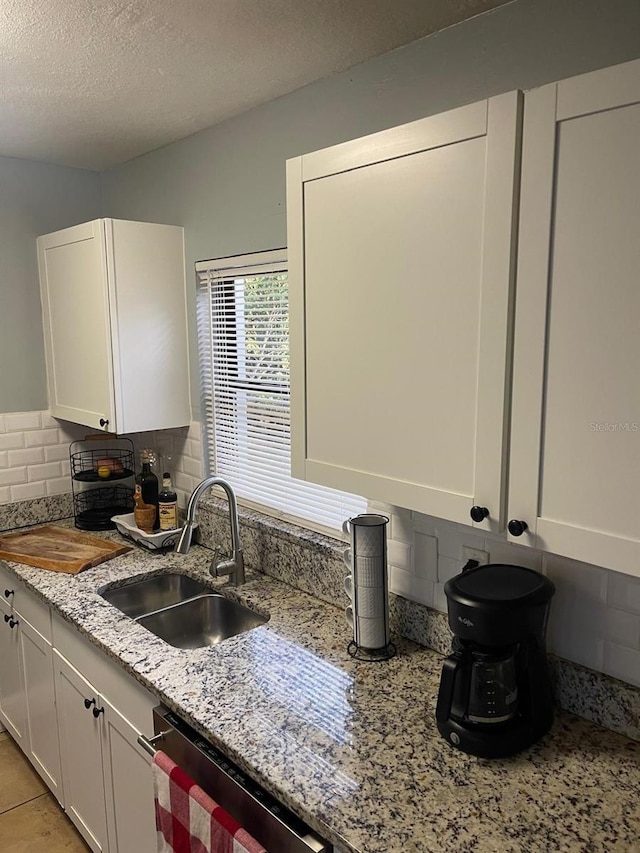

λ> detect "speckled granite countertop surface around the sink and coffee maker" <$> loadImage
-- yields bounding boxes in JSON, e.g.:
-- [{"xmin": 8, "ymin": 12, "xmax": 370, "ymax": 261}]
[{"xmin": 1, "ymin": 525, "xmax": 640, "ymax": 853}]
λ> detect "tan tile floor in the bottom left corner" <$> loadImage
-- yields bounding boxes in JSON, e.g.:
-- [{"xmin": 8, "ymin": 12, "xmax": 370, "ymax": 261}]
[{"xmin": 0, "ymin": 732, "xmax": 89, "ymax": 853}]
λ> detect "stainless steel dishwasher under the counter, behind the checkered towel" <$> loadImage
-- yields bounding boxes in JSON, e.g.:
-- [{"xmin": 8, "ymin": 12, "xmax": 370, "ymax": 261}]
[{"xmin": 138, "ymin": 705, "xmax": 333, "ymax": 853}]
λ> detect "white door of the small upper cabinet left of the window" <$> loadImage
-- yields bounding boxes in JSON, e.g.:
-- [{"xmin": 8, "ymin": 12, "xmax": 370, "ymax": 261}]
[{"xmin": 38, "ymin": 220, "xmax": 115, "ymax": 429}]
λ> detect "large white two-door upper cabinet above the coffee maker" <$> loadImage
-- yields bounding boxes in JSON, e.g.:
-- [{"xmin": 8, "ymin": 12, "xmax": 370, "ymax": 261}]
[{"xmin": 288, "ymin": 61, "xmax": 640, "ymax": 575}]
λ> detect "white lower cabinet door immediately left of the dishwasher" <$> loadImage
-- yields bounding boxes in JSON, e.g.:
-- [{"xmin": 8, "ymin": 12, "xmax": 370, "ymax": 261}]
[{"xmin": 102, "ymin": 697, "xmax": 157, "ymax": 853}]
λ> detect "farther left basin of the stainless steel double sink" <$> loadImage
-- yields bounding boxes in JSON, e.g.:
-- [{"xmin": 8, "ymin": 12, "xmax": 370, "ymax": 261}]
[{"xmin": 100, "ymin": 572, "xmax": 210, "ymax": 619}]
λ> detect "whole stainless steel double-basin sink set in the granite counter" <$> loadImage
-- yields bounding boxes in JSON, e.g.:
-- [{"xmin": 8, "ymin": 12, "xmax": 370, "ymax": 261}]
[{"xmin": 99, "ymin": 572, "xmax": 267, "ymax": 649}]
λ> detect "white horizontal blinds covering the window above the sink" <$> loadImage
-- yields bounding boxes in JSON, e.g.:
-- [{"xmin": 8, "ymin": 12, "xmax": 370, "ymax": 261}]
[{"xmin": 196, "ymin": 250, "xmax": 366, "ymax": 531}]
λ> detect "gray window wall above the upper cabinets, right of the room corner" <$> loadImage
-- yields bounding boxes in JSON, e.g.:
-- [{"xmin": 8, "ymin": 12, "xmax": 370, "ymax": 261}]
[{"xmin": 102, "ymin": 0, "xmax": 640, "ymax": 414}]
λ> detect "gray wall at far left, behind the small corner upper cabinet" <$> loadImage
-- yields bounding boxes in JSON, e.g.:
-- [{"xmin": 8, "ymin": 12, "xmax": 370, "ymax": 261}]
[{"xmin": 0, "ymin": 157, "xmax": 101, "ymax": 412}]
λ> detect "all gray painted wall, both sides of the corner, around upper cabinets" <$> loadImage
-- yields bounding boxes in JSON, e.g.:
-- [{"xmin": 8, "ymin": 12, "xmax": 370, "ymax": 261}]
[{"xmin": 5, "ymin": 0, "xmax": 640, "ymax": 412}]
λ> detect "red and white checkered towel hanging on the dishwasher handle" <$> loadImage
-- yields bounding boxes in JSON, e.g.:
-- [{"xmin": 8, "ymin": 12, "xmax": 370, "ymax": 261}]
[{"xmin": 153, "ymin": 750, "xmax": 267, "ymax": 853}]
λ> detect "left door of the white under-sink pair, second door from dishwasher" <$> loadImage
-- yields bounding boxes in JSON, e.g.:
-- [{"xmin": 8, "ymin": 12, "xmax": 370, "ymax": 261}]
[{"xmin": 53, "ymin": 650, "xmax": 108, "ymax": 851}]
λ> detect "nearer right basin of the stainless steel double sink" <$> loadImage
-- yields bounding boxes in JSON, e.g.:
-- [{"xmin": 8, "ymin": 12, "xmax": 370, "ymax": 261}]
[{"xmin": 136, "ymin": 594, "xmax": 267, "ymax": 649}]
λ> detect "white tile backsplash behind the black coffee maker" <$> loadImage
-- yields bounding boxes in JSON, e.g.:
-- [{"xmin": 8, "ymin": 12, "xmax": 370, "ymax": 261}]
[{"xmin": 378, "ymin": 503, "xmax": 640, "ymax": 687}]
